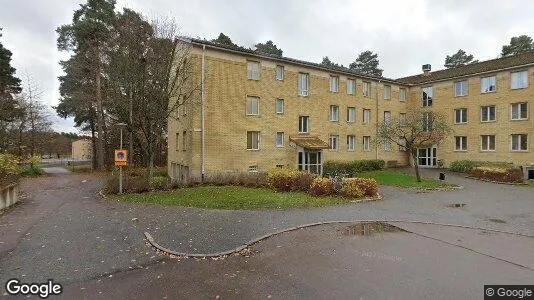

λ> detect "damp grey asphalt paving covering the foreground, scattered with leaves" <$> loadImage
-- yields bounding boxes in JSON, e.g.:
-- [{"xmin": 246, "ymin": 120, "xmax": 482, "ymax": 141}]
[{"xmin": 0, "ymin": 173, "xmax": 534, "ymax": 299}]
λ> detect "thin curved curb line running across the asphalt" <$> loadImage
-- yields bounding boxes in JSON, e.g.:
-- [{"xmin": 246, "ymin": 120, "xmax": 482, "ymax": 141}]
[{"xmin": 144, "ymin": 220, "xmax": 534, "ymax": 258}]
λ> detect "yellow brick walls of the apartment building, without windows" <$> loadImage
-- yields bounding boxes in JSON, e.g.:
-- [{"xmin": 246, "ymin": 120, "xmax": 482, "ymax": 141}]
[{"xmin": 168, "ymin": 39, "xmax": 534, "ymax": 179}]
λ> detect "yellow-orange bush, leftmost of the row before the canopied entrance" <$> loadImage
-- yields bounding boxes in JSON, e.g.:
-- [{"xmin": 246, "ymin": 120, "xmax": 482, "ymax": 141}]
[{"xmin": 267, "ymin": 168, "xmax": 314, "ymax": 192}]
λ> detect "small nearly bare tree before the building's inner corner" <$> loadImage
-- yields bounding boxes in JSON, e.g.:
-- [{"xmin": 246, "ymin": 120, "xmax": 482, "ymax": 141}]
[{"xmin": 375, "ymin": 109, "xmax": 452, "ymax": 182}]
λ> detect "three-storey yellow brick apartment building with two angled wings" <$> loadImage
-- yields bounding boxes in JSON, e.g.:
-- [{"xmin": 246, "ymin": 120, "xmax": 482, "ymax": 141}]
[{"xmin": 168, "ymin": 39, "xmax": 534, "ymax": 180}]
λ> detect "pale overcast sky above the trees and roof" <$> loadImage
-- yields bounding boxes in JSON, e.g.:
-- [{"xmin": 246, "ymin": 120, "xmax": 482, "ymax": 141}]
[{"xmin": 0, "ymin": 0, "xmax": 534, "ymax": 131}]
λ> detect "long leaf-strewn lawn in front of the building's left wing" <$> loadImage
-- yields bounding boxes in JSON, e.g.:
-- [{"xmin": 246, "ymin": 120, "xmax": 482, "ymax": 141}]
[{"xmin": 112, "ymin": 186, "xmax": 347, "ymax": 209}]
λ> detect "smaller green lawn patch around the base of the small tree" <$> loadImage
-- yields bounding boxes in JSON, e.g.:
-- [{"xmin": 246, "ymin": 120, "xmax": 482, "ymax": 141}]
[{"xmin": 356, "ymin": 170, "xmax": 453, "ymax": 189}]
